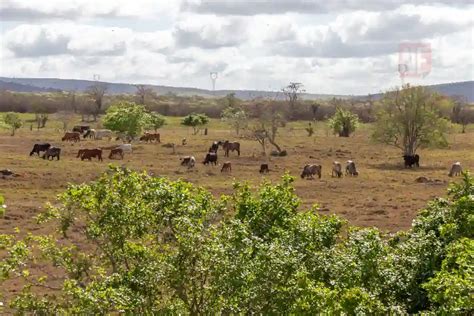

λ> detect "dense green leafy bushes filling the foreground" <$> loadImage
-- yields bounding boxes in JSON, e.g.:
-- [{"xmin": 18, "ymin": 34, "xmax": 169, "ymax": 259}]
[{"xmin": 0, "ymin": 168, "xmax": 474, "ymax": 315}]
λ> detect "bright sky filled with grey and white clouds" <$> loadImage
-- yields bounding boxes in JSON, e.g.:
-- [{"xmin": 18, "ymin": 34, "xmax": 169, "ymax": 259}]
[{"xmin": 0, "ymin": 0, "xmax": 474, "ymax": 94}]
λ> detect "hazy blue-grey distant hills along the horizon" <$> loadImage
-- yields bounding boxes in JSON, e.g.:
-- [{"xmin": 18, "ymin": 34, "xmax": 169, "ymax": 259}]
[{"xmin": 0, "ymin": 77, "xmax": 474, "ymax": 102}]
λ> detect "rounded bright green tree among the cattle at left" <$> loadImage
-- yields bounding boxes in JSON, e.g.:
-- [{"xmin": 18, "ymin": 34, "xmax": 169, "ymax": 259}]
[{"xmin": 103, "ymin": 102, "xmax": 150, "ymax": 139}]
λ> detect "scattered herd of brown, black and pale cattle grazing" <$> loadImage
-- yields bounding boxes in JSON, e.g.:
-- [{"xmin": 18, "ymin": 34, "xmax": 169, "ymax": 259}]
[{"xmin": 30, "ymin": 125, "xmax": 462, "ymax": 179}]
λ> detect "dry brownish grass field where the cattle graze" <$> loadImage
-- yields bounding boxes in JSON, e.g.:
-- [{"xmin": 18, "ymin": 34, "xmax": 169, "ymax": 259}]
[{"xmin": 0, "ymin": 114, "xmax": 474, "ymax": 242}]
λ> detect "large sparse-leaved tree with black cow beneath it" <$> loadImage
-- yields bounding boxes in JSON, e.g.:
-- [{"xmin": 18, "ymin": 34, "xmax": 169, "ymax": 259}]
[{"xmin": 372, "ymin": 85, "xmax": 448, "ymax": 155}]
